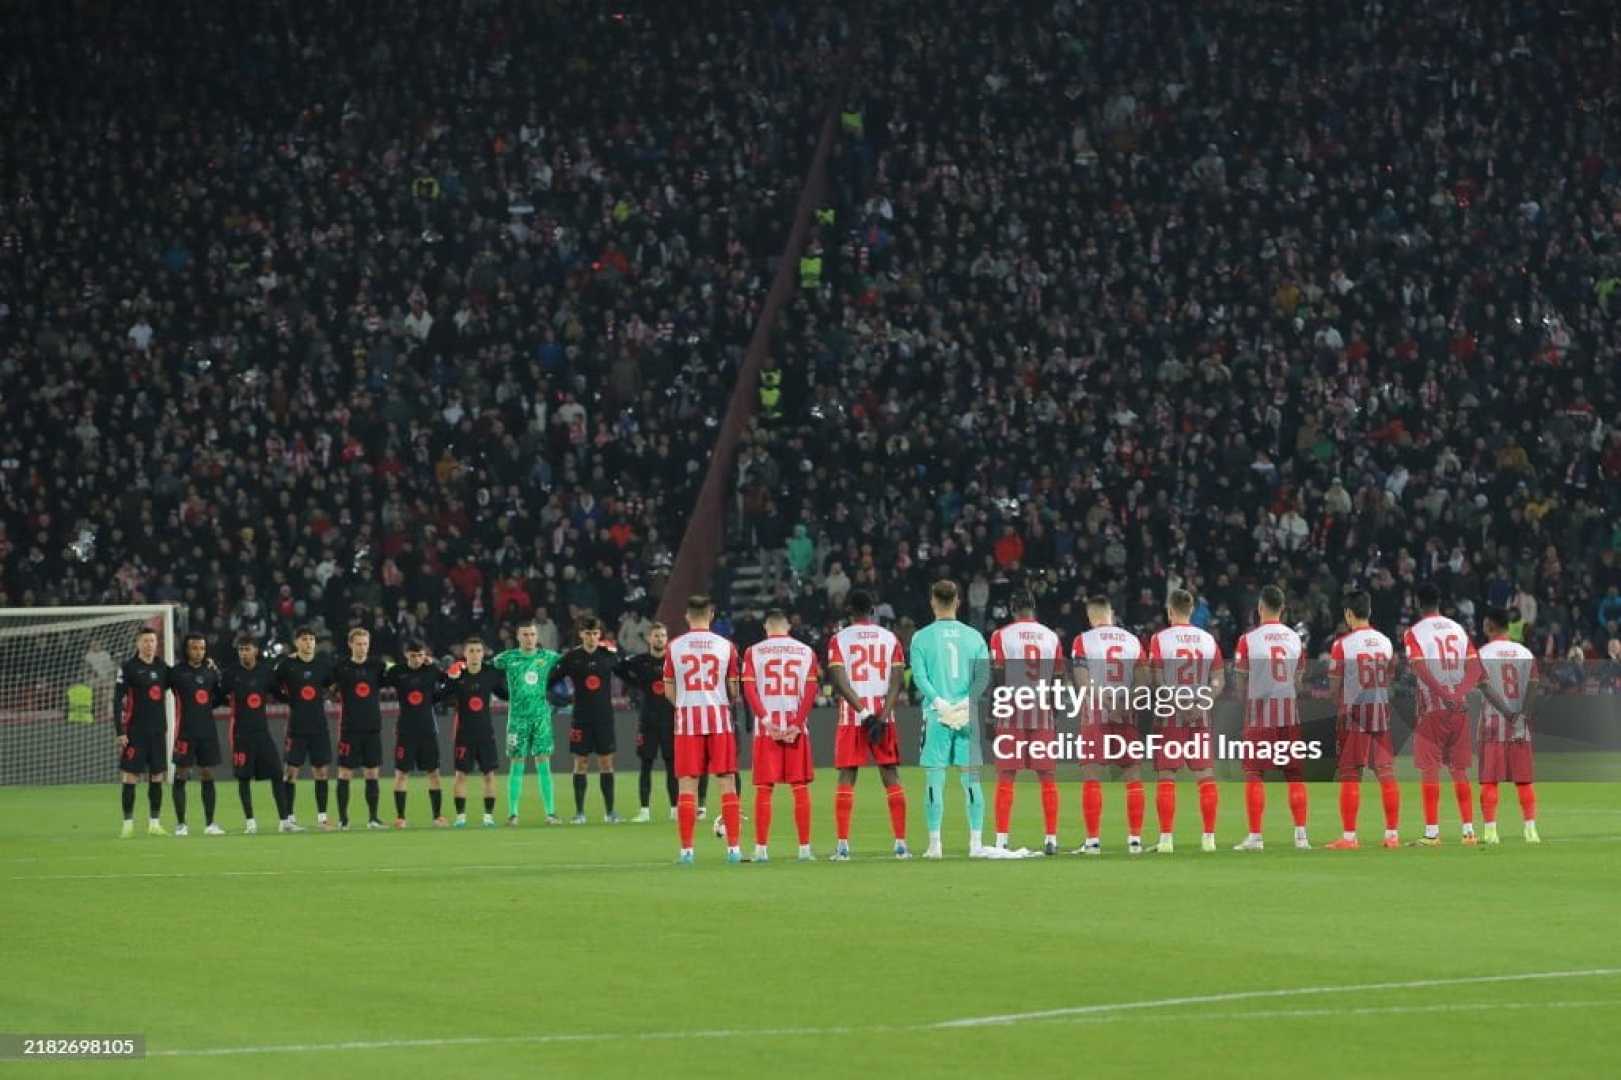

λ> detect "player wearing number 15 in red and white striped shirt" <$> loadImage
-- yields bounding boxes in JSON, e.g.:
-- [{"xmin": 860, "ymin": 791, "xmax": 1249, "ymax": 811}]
[{"xmin": 1402, "ymin": 582, "xmax": 1480, "ymax": 848}]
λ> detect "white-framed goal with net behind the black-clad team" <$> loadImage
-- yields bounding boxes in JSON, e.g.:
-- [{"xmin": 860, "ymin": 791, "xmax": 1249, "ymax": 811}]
[{"xmin": 0, "ymin": 605, "xmax": 175, "ymax": 785}]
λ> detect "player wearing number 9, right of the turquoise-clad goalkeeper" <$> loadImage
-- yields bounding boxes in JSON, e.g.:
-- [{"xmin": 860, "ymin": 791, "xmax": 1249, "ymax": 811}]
[{"xmin": 990, "ymin": 592, "xmax": 1063, "ymax": 855}]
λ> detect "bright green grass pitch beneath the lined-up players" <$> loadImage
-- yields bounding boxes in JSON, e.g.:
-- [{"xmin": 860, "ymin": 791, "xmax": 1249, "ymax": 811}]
[{"xmin": 0, "ymin": 770, "xmax": 1621, "ymax": 1080}]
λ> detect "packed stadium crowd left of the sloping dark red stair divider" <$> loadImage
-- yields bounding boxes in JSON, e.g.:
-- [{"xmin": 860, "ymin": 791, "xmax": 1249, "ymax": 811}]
[{"xmin": 0, "ymin": 0, "xmax": 848, "ymax": 655}]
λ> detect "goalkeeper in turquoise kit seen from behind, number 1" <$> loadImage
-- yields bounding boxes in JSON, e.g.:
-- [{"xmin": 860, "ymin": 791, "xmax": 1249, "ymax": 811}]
[{"xmin": 911, "ymin": 581, "xmax": 990, "ymax": 859}]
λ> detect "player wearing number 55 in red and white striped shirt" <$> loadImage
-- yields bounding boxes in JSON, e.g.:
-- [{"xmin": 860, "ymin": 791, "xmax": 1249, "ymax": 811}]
[{"xmin": 742, "ymin": 610, "xmax": 817, "ymax": 863}]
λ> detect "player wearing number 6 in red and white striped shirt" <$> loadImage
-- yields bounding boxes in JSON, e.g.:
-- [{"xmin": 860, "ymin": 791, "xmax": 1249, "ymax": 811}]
[{"xmin": 1232, "ymin": 585, "xmax": 1311, "ymax": 851}]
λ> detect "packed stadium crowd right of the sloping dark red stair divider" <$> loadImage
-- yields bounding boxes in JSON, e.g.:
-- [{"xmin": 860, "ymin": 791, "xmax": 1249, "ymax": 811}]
[{"xmin": 742, "ymin": 0, "xmax": 1621, "ymax": 660}]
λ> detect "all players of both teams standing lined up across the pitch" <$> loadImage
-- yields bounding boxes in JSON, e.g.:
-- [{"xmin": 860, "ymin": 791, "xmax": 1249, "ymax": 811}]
[{"xmin": 118, "ymin": 582, "xmax": 1538, "ymax": 863}]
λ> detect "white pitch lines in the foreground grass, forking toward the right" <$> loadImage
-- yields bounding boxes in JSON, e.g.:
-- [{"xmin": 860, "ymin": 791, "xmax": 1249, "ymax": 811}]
[{"xmin": 148, "ymin": 968, "xmax": 1621, "ymax": 1057}]
